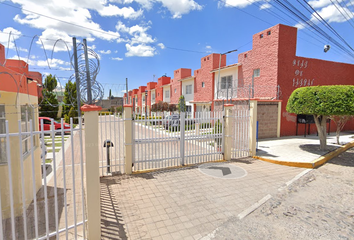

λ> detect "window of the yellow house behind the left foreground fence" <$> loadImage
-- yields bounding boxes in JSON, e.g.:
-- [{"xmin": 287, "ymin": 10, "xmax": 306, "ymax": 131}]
[{"xmin": 21, "ymin": 105, "xmax": 36, "ymax": 155}]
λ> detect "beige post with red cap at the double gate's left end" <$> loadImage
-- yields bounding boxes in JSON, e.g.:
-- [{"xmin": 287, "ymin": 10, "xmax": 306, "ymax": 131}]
[{"xmin": 123, "ymin": 105, "xmax": 133, "ymax": 174}]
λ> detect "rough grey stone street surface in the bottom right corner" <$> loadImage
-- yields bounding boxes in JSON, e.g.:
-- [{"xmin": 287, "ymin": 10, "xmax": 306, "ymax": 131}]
[{"xmin": 209, "ymin": 148, "xmax": 354, "ymax": 240}]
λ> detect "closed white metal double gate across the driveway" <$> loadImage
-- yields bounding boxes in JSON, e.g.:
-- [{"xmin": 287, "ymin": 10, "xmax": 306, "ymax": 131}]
[{"xmin": 133, "ymin": 112, "xmax": 224, "ymax": 171}]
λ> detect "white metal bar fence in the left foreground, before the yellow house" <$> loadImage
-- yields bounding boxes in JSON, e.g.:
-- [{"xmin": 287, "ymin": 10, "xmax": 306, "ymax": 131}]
[{"xmin": 0, "ymin": 118, "xmax": 86, "ymax": 239}]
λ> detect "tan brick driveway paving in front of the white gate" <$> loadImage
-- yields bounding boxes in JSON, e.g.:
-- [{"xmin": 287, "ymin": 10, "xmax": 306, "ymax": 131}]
[{"xmin": 101, "ymin": 158, "xmax": 303, "ymax": 239}]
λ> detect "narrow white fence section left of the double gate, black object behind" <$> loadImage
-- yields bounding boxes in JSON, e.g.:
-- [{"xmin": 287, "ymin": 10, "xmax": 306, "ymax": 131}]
[{"xmin": 98, "ymin": 114, "xmax": 124, "ymax": 176}]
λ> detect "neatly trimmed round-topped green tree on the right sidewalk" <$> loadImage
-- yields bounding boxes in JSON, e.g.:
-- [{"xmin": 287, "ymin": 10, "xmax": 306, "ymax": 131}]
[{"xmin": 286, "ymin": 85, "xmax": 354, "ymax": 150}]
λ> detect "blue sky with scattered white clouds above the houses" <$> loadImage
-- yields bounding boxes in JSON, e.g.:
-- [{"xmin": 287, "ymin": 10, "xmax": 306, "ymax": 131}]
[{"xmin": 0, "ymin": 0, "xmax": 354, "ymax": 97}]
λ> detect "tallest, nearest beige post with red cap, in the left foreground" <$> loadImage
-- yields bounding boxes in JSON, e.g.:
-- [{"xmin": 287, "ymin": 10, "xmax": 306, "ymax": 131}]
[{"xmin": 81, "ymin": 105, "xmax": 102, "ymax": 239}]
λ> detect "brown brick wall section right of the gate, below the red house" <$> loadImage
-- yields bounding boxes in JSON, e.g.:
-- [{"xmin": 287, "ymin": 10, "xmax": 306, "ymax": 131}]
[{"xmin": 257, "ymin": 102, "xmax": 278, "ymax": 139}]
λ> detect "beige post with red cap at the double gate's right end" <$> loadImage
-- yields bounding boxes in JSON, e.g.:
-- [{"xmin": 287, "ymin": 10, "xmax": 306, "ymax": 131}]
[{"xmin": 224, "ymin": 104, "xmax": 234, "ymax": 161}]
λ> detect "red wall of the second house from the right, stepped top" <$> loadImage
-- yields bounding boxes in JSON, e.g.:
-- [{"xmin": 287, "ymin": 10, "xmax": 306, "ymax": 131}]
[{"xmin": 194, "ymin": 53, "xmax": 226, "ymax": 108}]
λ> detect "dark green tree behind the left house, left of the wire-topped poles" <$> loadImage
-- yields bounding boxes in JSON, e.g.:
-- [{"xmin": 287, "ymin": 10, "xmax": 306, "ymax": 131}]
[{"xmin": 39, "ymin": 74, "xmax": 59, "ymax": 118}]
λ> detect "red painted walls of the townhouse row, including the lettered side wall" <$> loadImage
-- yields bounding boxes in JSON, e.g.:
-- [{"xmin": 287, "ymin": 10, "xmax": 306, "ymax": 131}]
[{"xmin": 126, "ymin": 24, "xmax": 354, "ymax": 136}]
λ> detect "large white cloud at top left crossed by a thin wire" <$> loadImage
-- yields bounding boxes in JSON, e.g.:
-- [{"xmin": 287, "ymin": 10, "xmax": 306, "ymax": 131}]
[{"xmin": 13, "ymin": 0, "xmax": 124, "ymax": 51}]
